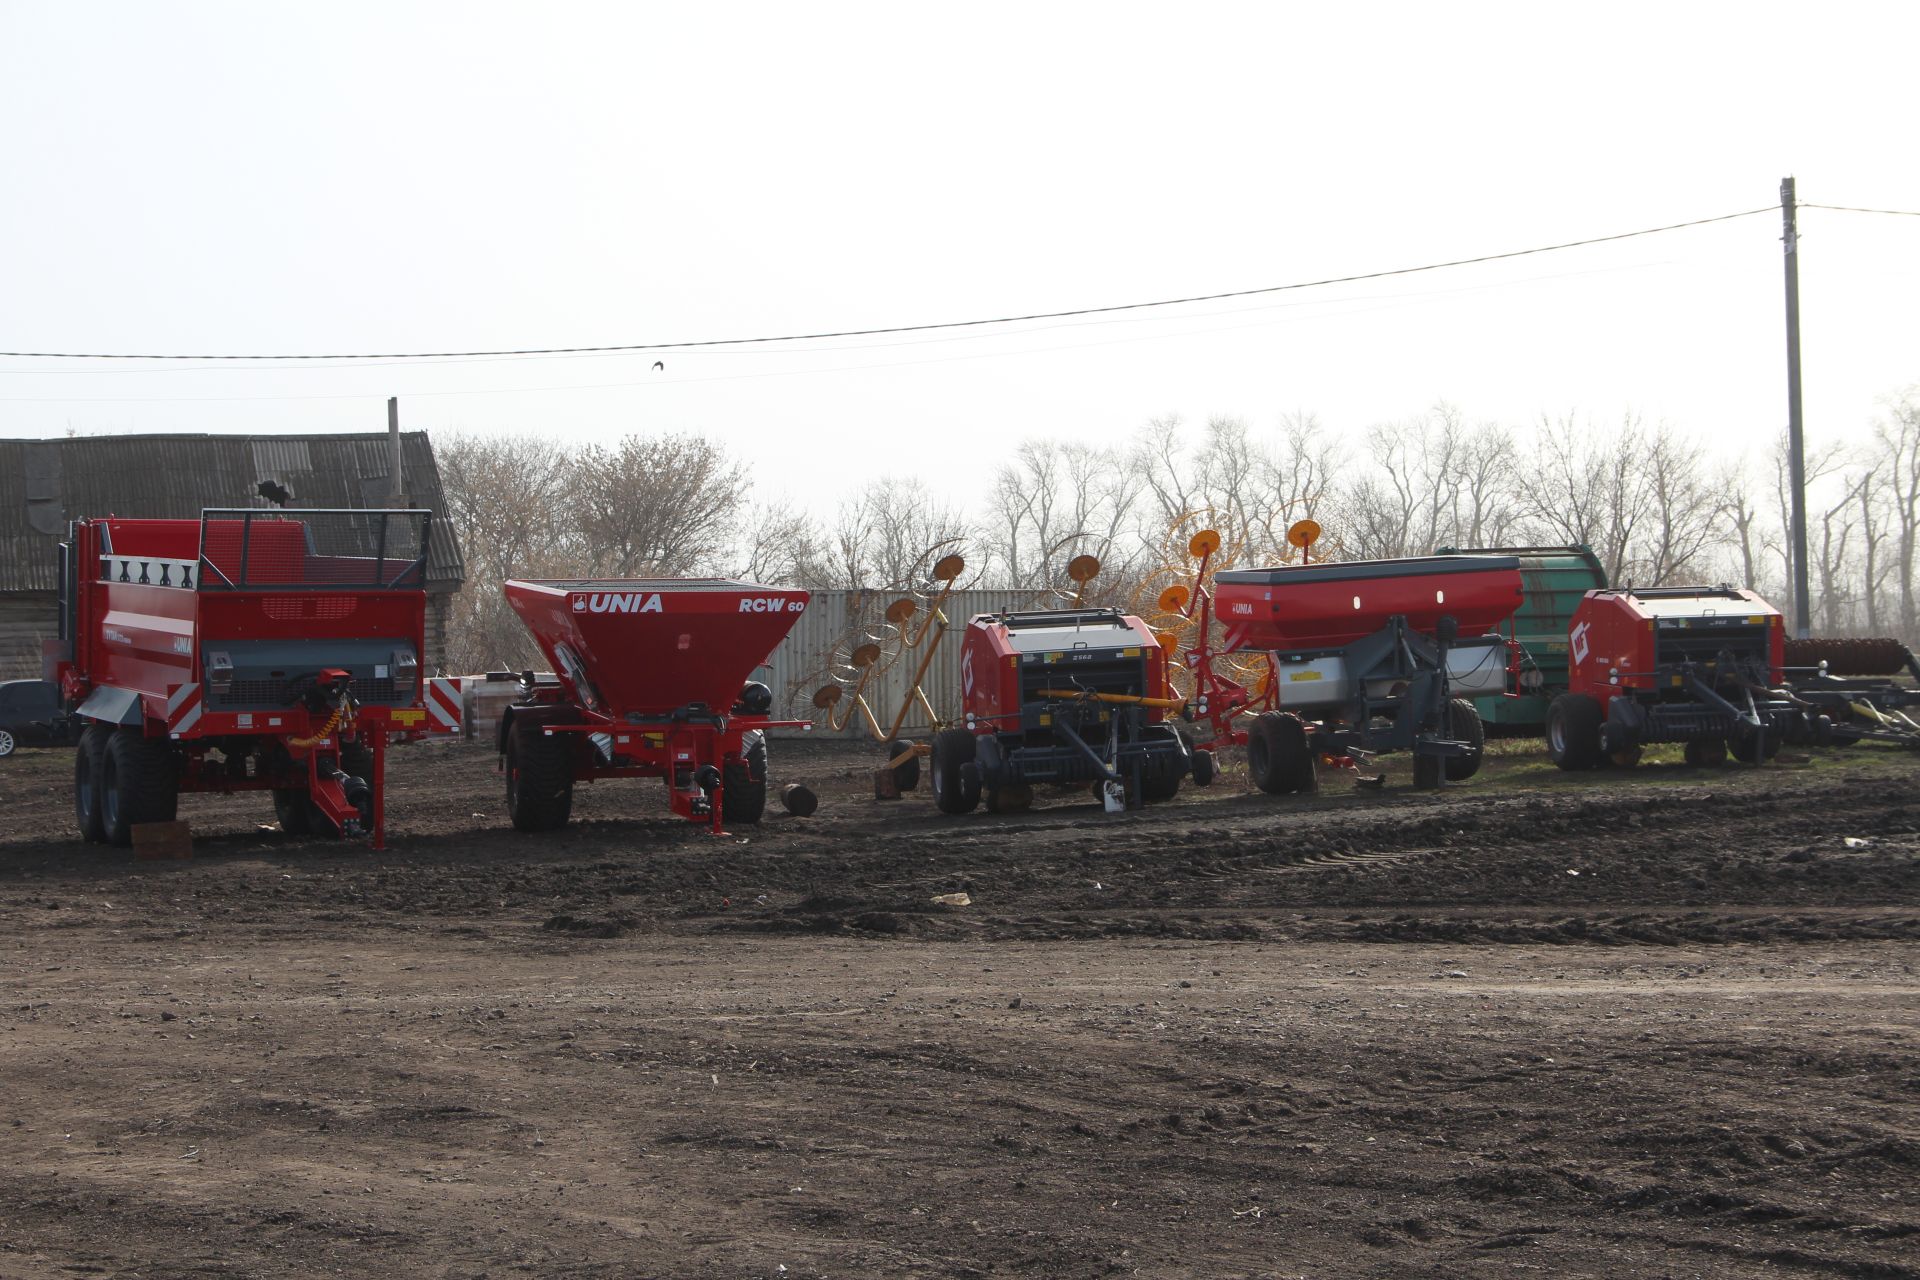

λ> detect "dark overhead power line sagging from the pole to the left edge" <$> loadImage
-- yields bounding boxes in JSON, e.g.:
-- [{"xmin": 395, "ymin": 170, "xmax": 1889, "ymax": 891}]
[{"xmin": 0, "ymin": 205, "xmax": 1778, "ymax": 361}]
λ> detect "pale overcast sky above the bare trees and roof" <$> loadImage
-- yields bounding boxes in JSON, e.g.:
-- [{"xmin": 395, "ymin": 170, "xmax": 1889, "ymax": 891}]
[{"xmin": 0, "ymin": 0, "xmax": 1920, "ymax": 510}]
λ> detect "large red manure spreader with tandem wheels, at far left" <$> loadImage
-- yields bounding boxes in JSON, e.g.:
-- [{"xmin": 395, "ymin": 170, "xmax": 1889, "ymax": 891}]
[{"xmin": 48, "ymin": 509, "xmax": 461, "ymax": 848}]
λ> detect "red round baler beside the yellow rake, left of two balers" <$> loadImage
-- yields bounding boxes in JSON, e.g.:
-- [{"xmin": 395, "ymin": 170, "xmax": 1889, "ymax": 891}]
[{"xmin": 933, "ymin": 608, "xmax": 1213, "ymax": 814}]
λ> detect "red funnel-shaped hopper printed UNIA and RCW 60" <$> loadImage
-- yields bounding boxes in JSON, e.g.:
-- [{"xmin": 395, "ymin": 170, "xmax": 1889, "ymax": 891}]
[{"xmin": 507, "ymin": 578, "xmax": 808, "ymax": 720}]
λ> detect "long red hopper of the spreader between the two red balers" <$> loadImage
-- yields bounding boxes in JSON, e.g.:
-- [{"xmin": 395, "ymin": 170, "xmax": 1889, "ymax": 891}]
[{"xmin": 1213, "ymin": 555, "xmax": 1521, "ymax": 652}]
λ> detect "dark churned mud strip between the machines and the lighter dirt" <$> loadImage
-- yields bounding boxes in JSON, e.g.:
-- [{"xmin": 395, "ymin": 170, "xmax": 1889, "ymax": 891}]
[{"xmin": 0, "ymin": 756, "xmax": 1920, "ymax": 944}]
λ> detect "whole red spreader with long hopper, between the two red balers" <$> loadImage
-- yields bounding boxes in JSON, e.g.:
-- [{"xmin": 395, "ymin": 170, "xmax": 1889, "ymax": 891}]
[{"xmin": 1162, "ymin": 526, "xmax": 1521, "ymax": 794}]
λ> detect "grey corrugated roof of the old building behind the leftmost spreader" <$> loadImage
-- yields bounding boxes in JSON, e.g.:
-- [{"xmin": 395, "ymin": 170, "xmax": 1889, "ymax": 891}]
[{"xmin": 0, "ymin": 432, "xmax": 465, "ymax": 591}]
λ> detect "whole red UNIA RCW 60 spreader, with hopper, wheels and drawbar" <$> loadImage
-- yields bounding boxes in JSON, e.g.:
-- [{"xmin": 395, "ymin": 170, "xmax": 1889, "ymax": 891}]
[{"xmin": 499, "ymin": 578, "xmax": 814, "ymax": 835}]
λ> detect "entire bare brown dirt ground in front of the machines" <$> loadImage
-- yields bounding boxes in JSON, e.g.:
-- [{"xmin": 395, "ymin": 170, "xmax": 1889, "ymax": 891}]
[{"xmin": 0, "ymin": 729, "xmax": 1920, "ymax": 1280}]
